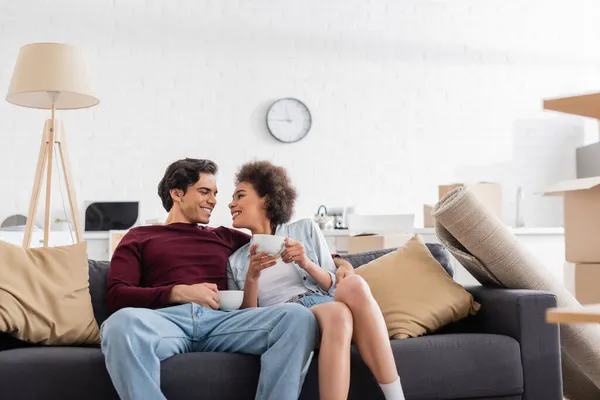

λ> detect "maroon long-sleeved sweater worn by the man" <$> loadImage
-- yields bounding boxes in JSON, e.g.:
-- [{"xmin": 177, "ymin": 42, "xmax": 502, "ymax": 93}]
[{"xmin": 107, "ymin": 223, "xmax": 250, "ymax": 312}]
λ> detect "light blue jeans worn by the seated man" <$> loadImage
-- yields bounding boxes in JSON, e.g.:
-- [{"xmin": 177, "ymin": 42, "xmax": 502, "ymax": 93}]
[{"xmin": 100, "ymin": 303, "xmax": 319, "ymax": 400}]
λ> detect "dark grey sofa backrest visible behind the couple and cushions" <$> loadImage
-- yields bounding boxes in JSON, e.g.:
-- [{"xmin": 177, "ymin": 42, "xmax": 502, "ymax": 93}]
[{"xmin": 88, "ymin": 243, "xmax": 454, "ymax": 326}]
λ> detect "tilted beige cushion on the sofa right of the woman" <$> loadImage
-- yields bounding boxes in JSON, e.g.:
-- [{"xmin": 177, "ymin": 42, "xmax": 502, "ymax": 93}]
[{"xmin": 356, "ymin": 235, "xmax": 480, "ymax": 339}]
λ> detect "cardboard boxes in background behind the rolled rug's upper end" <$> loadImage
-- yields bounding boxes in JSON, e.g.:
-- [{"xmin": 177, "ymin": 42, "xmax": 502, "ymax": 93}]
[{"xmin": 423, "ymin": 182, "xmax": 502, "ymax": 228}]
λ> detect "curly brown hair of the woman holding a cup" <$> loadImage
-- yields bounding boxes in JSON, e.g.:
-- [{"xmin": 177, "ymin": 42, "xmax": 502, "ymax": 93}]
[{"xmin": 235, "ymin": 161, "xmax": 296, "ymax": 233}]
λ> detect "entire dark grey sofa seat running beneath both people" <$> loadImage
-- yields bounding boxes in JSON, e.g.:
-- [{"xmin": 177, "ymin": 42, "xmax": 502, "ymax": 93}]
[{"xmin": 0, "ymin": 334, "xmax": 523, "ymax": 400}]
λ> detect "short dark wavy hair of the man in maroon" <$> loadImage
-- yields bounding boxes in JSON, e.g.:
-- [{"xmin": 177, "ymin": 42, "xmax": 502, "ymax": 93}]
[{"xmin": 158, "ymin": 158, "xmax": 218, "ymax": 212}]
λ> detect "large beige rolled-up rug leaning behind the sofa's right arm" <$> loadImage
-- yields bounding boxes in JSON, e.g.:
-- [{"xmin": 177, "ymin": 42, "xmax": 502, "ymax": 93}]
[{"xmin": 432, "ymin": 187, "xmax": 600, "ymax": 400}]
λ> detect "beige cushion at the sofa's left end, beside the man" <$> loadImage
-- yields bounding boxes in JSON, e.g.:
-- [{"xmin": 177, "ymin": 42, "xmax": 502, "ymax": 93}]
[{"xmin": 0, "ymin": 241, "xmax": 100, "ymax": 345}]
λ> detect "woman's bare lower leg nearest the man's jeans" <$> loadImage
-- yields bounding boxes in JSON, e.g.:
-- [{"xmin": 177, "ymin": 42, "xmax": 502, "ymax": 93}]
[{"xmin": 310, "ymin": 302, "xmax": 352, "ymax": 400}]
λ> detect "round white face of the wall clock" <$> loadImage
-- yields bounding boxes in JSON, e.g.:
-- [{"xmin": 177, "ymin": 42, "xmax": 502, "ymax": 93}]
[{"xmin": 267, "ymin": 99, "xmax": 312, "ymax": 143}]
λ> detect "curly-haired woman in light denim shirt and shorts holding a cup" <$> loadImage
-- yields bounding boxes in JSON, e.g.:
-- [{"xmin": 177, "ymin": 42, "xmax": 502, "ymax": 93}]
[{"xmin": 228, "ymin": 161, "xmax": 404, "ymax": 400}]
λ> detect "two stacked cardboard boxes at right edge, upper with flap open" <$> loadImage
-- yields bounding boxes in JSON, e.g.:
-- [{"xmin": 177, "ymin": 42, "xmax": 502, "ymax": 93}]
[{"xmin": 544, "ymin": 176, "xmax": 600, "ymax": 304}]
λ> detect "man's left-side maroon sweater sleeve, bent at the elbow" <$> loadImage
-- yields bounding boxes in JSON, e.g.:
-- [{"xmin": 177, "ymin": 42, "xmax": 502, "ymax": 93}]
[{"xmin": 106, "ymin": 230, "xmax": 174, "ymax": 313}]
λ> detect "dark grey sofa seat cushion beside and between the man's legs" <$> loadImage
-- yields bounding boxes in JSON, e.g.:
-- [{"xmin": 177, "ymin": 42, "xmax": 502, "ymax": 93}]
[{"xmin": 0, "ymin": 347, "xmax": 260, "ymax": 400}]
